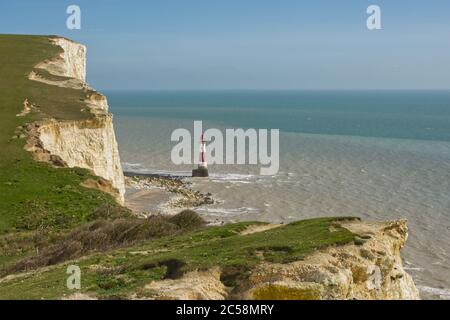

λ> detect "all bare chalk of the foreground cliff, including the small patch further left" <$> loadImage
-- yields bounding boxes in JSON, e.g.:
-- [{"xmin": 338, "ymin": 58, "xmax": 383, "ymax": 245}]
[{"xmin": 145, "ymin": 220, "xmax": 420, "ymax": 300}]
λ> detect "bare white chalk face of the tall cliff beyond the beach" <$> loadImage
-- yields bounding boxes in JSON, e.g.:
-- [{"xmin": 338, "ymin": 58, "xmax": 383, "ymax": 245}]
[{"xmin": 26, "ymin": 38, "xmax": 125, "ymax": 203}]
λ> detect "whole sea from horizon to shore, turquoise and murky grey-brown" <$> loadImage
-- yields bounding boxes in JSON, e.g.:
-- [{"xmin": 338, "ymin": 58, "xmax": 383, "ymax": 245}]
[{"xmin": 105, "ymin": 91, "xmax": 450, "ymax": 299}]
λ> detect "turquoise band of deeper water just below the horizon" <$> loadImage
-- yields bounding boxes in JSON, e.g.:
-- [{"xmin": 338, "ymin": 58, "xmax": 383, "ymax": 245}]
[{"xmin": 107, "ymin": 91, "xmax": 450, "ymax": 141}]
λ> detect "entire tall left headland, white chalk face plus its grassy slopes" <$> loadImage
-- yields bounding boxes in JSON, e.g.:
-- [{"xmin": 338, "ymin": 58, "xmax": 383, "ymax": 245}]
[{"xmin": 0, "ymin": 34, "xmax": 129, "ymax": 235}]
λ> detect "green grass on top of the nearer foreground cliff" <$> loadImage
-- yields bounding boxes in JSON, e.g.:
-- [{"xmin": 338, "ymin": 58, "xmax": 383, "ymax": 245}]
[{"xmin": 0, "ymin": 218, "xmax": 354, "ymax": 299}]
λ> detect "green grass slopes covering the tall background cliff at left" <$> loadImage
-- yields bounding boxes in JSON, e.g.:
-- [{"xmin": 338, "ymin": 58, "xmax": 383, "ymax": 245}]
[{"xmin": 0, "ymin": 35, "xmax": 125, "ymax": 235}]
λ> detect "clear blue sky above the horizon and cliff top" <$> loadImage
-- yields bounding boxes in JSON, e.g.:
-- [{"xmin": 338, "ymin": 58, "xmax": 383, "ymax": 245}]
[{"xmin": 0, "ymin": 0, "xmax": 450, "ymax": 90}]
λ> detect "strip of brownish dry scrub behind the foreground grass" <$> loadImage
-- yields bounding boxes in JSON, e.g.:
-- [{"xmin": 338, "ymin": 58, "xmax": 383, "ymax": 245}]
[{"xmin": 4, "ymin": 210, "xmax": 205, "ymax": 274}]
